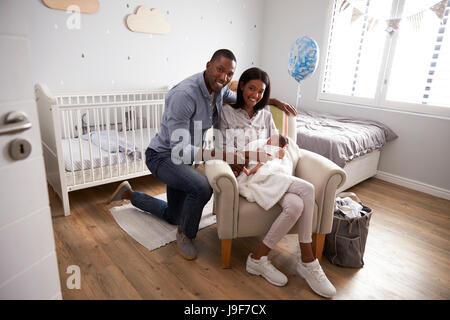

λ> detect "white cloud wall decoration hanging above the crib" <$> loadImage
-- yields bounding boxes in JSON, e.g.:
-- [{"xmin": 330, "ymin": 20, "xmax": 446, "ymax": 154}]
[{"xmin": 127, "ymin": 6, "xmax": 170, "ymax": 34}]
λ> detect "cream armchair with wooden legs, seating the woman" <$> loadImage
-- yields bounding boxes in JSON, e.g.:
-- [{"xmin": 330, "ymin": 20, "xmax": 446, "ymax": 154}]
[{"xmin": 205, "ymin": 107, "xmax": 346, "ymax": 268}]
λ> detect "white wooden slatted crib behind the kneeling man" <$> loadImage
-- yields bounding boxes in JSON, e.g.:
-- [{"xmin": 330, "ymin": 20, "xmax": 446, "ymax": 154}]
[{"xmin": 35, "ymin": 84, "xmax": 167, "ymax": 216}]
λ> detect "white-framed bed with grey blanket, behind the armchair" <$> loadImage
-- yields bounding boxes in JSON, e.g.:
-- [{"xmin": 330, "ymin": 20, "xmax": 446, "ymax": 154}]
[{"xmin": 296, "ymin": 109, "xmax": 398, "ymax": 192}]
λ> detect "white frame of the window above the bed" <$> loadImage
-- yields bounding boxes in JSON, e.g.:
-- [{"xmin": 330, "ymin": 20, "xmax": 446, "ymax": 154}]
[{"xmin": 316, "ymin": 0, "xmax": 450, "ymax": 118}]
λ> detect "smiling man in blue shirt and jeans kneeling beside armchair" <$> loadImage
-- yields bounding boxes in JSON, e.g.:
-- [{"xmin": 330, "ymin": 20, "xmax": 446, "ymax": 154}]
[{"xmin": 110, "ymin": 49, "xmax": 296, "ymax": 260}]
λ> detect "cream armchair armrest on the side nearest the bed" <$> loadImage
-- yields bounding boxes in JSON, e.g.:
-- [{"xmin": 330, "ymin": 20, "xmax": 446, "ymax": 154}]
[{"xmin": 295, "ymin": 149, "xmax": 347, "ymax": 234}]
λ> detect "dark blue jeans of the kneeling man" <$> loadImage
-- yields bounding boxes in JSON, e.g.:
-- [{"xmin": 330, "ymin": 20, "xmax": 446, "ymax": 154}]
[{"xmin": 131, "ymin": 148, "xmax": 213, "ymax": 239}]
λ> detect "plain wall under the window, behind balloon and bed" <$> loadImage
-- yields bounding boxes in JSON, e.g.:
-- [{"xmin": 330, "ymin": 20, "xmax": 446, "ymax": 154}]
[{"xmin": 261, "ymin": 0, "xmax": 450, "ymax": 197}]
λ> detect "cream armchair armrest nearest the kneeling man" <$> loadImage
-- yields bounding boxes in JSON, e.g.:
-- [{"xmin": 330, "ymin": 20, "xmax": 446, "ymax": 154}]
[{"xmin": 205, "ymin": 160, "xmax": 239, "ymax": 239}]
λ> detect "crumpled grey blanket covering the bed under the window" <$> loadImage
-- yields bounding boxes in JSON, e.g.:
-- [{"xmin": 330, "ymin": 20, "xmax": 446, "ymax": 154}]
[{"xmin": 297, "ymin": 110, "xmax": 397, "ymax": 168}]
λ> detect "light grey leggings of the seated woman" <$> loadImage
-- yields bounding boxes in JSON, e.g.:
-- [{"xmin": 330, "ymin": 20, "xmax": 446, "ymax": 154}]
[{"xmin": 263, "ymin": 178, "xmax": 314, "ymax": 249}]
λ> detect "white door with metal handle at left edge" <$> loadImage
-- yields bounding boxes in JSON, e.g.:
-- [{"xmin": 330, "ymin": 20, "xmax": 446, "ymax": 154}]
[{"xmin": 0, "ymin": 0, "xmax": 61, "ymax": 300}]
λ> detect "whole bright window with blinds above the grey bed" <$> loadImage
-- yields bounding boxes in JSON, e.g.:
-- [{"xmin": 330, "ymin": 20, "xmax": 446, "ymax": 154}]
[{"xmin": 319, "ymin": 0, "xmax": 450, "ymax": 116}]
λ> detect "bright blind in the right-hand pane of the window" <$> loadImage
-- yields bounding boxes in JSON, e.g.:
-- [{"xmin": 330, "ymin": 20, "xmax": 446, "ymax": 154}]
[{"xmin": 386, "ymin": 1, "xmax": 450, "ymax": 107}]
